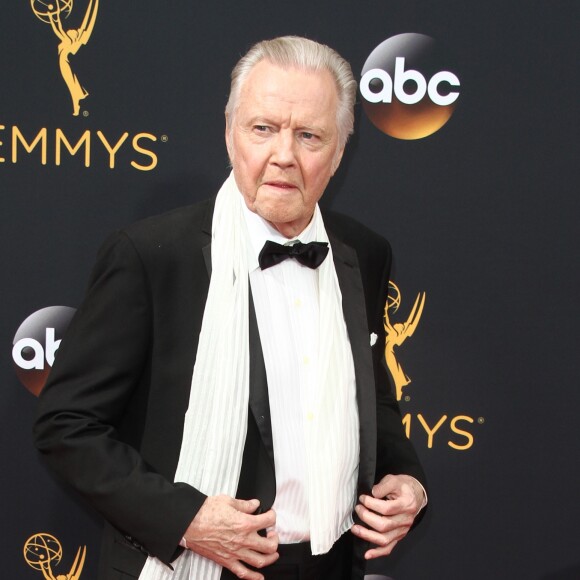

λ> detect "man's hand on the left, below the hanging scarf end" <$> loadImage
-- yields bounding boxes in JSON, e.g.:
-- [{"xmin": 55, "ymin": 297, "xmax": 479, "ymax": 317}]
[{"xmin": 185, "ymin": 495, "xmax": 278, "ymax": 580}]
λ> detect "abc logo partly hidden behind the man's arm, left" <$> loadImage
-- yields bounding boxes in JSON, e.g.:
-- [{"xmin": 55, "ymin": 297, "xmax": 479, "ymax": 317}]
[{"xmin": 12, "ymin": 306, "xmax": 75, "ymax": 396}]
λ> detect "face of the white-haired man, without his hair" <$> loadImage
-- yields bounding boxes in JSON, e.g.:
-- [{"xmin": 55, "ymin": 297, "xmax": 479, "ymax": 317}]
[{"xmin": 226, "ymin": 60, "xmax": 343, "ymax": 238}]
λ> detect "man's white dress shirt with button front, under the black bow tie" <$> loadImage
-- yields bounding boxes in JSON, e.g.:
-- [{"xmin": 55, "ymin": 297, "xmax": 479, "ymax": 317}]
[{"xmin": 244, "ymin": 208, "xmax": 359, "ymax": 544}]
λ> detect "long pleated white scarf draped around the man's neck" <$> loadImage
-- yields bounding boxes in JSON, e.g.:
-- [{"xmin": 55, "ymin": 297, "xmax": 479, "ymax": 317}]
[{"xmin": 139, "ymin": 174, "xmax": 358, "ymax": 580}]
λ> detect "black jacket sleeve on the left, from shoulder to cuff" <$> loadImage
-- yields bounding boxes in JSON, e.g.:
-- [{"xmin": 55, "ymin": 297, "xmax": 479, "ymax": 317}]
[{"xmin": 34, "ymin": 233, "xmax": 205, "ymax": 563}]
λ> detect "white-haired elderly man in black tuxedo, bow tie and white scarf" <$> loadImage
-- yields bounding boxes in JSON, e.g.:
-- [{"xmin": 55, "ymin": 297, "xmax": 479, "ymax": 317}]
[{"xmin": 35, "ymin": 37, "xmax": 426, "ymax": 580}]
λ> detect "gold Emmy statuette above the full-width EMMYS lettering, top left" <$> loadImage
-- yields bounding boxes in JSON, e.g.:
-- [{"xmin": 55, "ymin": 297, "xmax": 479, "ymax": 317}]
[{"xmin": 30, "ymin": 0, "xmax": 99, "ymax": 116}]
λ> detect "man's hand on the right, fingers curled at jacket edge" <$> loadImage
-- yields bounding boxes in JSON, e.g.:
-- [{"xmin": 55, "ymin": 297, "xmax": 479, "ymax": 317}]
[{"xmin": 351, "ymin": 475, "xmax": 425, "ymax": 560}]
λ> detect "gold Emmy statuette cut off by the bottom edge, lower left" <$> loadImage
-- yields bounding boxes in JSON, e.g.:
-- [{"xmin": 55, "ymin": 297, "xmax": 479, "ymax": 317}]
[{"xmin": 24, "ymin": 534, "xmax": 87, "ymax": 580}]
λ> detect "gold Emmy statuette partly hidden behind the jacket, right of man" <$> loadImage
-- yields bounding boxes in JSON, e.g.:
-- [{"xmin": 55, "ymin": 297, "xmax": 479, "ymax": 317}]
[{"xmin": 383, "ymin": 282, "xmax": 425, "ymax": 401}]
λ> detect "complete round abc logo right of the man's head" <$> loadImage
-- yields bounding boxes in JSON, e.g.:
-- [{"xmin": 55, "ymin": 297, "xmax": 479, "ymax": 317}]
[{"xmin": 360, "ymin": 33, "xmax": 460, "ymax": 139}]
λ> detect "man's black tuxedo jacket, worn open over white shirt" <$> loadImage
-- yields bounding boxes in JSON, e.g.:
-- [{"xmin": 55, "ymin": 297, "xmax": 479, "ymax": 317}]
[{"xmin": 35, "ymin": 201, "xmax": 425, "ymax": 580}]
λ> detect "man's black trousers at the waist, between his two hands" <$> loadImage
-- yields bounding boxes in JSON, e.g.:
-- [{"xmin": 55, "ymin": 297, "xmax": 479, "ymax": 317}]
[{"xmin": 221, "ymin": 532, "xmax": 352, "ymax": 580}]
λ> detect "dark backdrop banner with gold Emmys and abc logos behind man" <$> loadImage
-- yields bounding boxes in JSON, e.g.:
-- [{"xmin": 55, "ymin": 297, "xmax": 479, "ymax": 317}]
[{"xmin": 0, "ymin": 0, "xmax": 580, "ymax": 580}]
